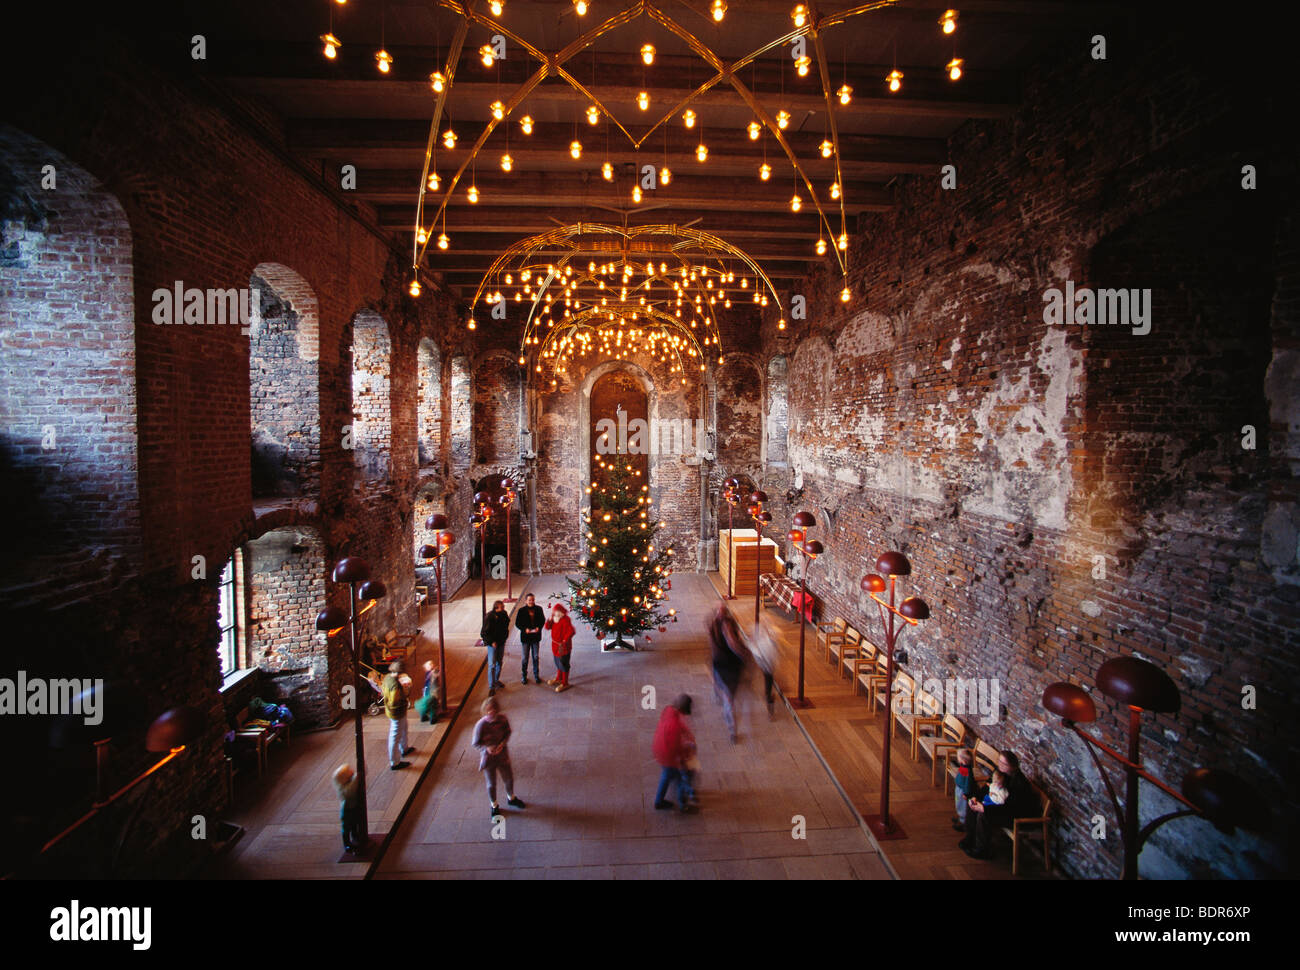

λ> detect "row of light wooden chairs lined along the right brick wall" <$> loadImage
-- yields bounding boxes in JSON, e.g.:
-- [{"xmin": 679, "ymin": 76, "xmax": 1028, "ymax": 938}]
[{"xmin": 816, "ymin": 618, "xmax": 1052, "ymax": 874}]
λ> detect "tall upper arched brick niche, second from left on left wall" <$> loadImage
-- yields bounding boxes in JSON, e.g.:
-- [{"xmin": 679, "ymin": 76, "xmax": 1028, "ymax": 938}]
[{"xmin": 248, "ymin": 263, "xmax": 320, "ymax": 498}]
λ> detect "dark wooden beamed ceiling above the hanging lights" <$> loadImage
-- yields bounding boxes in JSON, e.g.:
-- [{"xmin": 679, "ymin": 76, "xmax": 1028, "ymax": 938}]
[{"xmin": 174, "ymin": 0, "xmax": 1117, "ymax": 293}]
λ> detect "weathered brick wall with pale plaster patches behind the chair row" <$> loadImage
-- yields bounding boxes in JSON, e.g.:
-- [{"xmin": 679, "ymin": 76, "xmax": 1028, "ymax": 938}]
[{"xmin": 764, "ymin": 24, "xmax": 1300, "ymax": 876}]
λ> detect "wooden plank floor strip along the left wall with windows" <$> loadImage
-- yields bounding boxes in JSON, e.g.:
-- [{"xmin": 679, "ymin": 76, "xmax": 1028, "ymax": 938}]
[{"xmin": 203, "ymin": 576, "xmax": 520, "ymax": 879}]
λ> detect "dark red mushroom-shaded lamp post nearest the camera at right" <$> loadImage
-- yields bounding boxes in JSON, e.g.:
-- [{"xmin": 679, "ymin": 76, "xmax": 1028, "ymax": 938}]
[{"xmin": 1043, "ymin": 657, "xmax": 1268, "ymax": 879}]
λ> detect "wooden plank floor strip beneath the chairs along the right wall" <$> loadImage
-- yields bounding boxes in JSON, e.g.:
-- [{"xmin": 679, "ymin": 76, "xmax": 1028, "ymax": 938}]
[{"xmin": 709, "ymin": 572, "xmax": 1045, "ymax": 879}]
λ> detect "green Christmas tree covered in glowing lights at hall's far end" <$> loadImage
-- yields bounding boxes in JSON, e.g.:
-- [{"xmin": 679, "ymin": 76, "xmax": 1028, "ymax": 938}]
[{"xmin": 568, "ymin": 455, "xmax": 677, "ymax": 649}]
